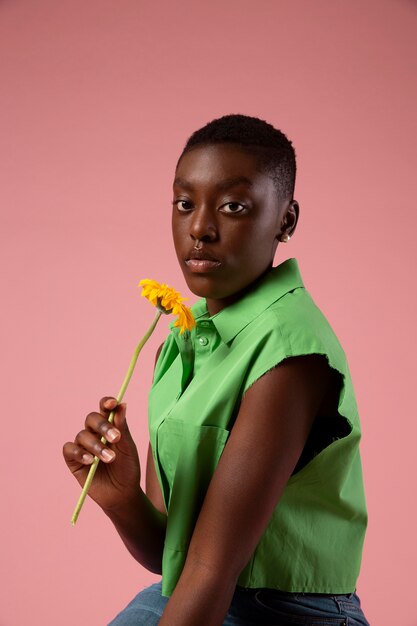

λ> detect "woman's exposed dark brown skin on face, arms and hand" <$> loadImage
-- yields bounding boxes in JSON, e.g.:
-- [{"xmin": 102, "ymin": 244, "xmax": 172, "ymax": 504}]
[{"xmin": 64, "ymin": 144, "xmax": 334, "ymax": 626}]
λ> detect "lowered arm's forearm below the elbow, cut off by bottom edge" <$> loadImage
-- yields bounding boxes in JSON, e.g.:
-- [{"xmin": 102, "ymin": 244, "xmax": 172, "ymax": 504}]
[{"xmin": 159, "ymin": 565, "xmax": 236, "ymax": 626}]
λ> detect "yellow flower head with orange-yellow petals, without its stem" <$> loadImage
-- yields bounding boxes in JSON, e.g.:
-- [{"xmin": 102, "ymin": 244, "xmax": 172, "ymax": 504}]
[{"xmin": 139, "ymin": 278, "xmax": 195, "ymax": 333}]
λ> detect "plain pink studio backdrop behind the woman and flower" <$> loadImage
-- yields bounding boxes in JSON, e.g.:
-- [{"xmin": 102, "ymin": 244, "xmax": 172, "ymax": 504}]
[{"xmin": 0, "ymin": 0, "xmax": 417, "ymax": 626}]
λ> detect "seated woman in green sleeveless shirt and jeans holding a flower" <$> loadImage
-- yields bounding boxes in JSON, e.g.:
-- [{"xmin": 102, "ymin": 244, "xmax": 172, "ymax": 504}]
[{"xmin": 64, "ymin": 115, "xmax": 367, "ymax": 626}]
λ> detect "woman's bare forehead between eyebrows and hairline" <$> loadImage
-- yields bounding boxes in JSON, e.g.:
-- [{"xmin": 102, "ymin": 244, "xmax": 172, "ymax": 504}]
[{"xmin": 174, "ymin": 144, "xmax": 265, "ymax": 186}]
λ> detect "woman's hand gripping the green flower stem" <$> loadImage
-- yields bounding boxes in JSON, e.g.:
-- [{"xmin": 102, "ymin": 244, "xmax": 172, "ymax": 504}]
[{"xmin": 63, "ymin": 397, "xmax": 140, "ymax": 511}]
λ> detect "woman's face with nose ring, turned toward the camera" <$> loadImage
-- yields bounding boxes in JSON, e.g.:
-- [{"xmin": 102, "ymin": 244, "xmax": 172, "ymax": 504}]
[{"xmin": 172, "ymin": 144, "xmax": 295, "ymax": 315}]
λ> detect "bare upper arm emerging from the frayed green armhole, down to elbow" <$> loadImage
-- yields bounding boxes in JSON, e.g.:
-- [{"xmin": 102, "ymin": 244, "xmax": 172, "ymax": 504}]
[{"xmin": 187, "ymin": 355, "xmax": 331, "ymax": 578}]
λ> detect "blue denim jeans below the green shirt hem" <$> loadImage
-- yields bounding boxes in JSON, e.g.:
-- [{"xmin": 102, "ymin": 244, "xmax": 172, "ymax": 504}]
[{"xmin": 108, "ymin": 582, "xmax": 369, "ymax": 626}]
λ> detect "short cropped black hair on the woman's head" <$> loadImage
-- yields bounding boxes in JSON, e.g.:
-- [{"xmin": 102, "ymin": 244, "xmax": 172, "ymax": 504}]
[{"xmin": 177, "ymin": 113, "xmax": 296, "ymax": 200}]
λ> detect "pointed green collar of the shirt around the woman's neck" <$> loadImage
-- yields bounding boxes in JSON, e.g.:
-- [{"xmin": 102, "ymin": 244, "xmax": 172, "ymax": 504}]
[{"xmin": 174, "ymin": 259, "xmax": 304, "ymax": 343}]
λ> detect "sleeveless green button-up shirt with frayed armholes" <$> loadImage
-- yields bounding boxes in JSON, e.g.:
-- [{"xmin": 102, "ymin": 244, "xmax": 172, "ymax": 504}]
[{"xmin": 149, "ymin": 259, "xmax": 367, "ymax": 596}]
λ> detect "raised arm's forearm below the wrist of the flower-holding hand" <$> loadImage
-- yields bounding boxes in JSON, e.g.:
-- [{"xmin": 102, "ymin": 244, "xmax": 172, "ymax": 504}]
[{"xmin": 105, "ymin": 489, "xmax": 167, "ymax": 574}]
